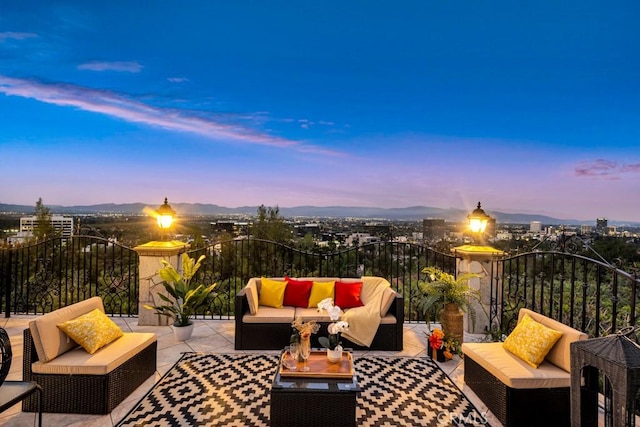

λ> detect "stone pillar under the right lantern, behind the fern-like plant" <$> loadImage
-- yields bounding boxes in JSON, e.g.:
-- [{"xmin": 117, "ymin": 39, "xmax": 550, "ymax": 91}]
[{"xmin": 452, "ymin": 245, "xmax": 505, "ymax": 334}]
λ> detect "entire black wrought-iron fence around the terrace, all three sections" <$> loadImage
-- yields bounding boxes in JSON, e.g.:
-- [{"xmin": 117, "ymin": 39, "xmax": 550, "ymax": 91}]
[{"xmin": 0, "ymin": 236, "xmax": 640, "ymax": 337}]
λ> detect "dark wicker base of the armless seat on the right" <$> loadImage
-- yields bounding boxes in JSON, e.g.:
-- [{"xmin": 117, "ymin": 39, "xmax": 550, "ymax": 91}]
[{"xmin": 464, "ymin": 355, "xmax": 571, "ymax": 427}]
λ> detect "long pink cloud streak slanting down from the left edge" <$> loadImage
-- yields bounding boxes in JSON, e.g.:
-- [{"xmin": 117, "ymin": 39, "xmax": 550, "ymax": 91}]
[{"xmin": 0, "ymin": 75, "xmax": 342, "ymax": 155}]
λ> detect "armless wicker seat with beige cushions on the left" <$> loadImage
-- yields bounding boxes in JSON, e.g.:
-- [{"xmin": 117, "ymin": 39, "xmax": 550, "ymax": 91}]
[{"xmin": 22, "ymin": 297, "xmax": 157, "ymax": 414}]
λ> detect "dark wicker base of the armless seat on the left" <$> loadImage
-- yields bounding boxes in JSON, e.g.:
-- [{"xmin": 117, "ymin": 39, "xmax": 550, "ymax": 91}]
[{"xmin": 22, "ymin": 328, "xmax": 158, "ymax": 414}]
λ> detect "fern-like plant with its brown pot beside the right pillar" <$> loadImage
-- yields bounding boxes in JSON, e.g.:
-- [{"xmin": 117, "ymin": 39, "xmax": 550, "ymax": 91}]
[{"xmin": 418, "ymin": 267, "xmax": 482, "ymax": 343}]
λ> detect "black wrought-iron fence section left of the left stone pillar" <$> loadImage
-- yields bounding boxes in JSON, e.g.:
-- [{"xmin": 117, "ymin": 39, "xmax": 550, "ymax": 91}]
[{"xmin": 0, "ymin": 236, "xmax": 138, "ymax": 316}]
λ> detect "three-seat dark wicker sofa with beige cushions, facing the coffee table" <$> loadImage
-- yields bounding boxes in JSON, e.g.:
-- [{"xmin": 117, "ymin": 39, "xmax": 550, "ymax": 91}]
[{"xmin": 235, "ymin": 276, "xmax": 404, "ymax": 351}]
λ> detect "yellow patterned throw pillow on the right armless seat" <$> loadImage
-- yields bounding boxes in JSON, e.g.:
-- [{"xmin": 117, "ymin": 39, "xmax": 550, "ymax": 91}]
[{"xmin": 502, "ymin": 314, "xmax": 562, "ymax": 369}]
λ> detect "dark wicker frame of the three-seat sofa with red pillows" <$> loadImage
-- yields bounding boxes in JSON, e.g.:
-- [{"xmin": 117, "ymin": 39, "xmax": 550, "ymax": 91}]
[{"xmin": 235, "ymin": 288, "xmax": 404, "ymax": 351}]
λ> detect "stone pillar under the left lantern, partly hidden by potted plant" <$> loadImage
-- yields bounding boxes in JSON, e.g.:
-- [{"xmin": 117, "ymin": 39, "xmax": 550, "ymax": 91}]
[{"xmin": 134, "ymin": 241, "xmax": 189, "ymax": 326}]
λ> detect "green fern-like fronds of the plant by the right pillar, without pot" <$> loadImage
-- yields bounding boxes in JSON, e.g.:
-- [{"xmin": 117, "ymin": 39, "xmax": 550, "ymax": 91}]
[{"xmin": 417, "ymin": 267, "xmax": 482, "ymax": 330}]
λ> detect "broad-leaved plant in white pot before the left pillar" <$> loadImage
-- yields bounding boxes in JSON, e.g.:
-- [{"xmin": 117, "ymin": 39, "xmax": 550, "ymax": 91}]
[{"xmin": 144, "ymin": 253, "xmax": 216, "ymax": 341}]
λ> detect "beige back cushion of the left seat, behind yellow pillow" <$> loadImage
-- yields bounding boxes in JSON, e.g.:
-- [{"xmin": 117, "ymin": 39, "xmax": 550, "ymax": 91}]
[{"xmin": 29, "ymin": 297, "xmax": 104, "ymax": 362}]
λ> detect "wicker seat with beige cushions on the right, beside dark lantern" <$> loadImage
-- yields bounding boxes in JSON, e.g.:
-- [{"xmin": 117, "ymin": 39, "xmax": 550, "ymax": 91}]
[{"xmin": 462, "ymin": 308, "xmax": 588, "ymax": 427}]
